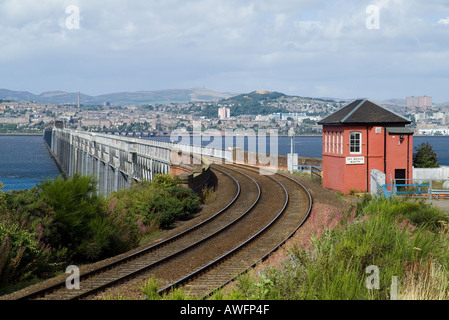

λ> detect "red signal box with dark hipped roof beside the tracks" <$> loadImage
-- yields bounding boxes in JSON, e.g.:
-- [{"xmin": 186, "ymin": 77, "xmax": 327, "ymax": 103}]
[{"xmin": 318, "ymin": 100, "xmax": 413, "ymax": 193}]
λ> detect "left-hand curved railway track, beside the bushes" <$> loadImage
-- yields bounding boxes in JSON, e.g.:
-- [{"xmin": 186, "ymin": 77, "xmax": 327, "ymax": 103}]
[{"xmin": 14, "ymin": 165, "xmax": 260, "ymax": 300}]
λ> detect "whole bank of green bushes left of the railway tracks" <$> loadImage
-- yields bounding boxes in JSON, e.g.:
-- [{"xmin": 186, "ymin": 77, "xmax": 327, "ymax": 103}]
[{"xmin": 0, "ymin": 175, "xmax": 201, "ymax": 293}]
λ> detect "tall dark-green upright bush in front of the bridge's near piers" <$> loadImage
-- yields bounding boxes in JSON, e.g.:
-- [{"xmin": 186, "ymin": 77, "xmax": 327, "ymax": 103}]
[{"xmin": 38, "ymin": 175, "xmax": 114, "ymax": 261}]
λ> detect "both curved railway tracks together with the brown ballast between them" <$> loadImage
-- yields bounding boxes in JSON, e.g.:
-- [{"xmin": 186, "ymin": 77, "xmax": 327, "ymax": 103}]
[{"xmin": 19, "ymin": 165, "xmax": 312, "ymax": 300}]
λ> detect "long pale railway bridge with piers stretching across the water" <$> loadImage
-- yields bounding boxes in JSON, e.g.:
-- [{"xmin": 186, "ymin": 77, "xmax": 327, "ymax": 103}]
[{"xmin": 44, "ymin": 127, "xmax": 232, "ymax": 195}]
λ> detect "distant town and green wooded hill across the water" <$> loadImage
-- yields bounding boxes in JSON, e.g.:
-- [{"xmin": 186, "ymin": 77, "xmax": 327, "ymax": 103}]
[{"xmin": 0, "ymin": 91, "xmax": 449, "ymax": 136}]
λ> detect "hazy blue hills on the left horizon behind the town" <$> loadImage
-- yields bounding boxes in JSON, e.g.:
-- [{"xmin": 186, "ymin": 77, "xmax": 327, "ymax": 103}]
[{"xmin": 0, "ymin": 88, "xmax": 235, "ymax": 105}]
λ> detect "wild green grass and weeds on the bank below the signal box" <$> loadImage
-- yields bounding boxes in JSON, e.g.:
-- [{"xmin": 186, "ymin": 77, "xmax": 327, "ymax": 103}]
[{"xmin": 210, "ymin": 199, "xmax": 449, "ymax": 300}]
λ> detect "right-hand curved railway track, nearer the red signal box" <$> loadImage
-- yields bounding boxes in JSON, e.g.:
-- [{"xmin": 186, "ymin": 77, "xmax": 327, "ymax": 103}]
[{"xmin": 159, "ymin": 165, "xmax": 312, "ymax": 298}]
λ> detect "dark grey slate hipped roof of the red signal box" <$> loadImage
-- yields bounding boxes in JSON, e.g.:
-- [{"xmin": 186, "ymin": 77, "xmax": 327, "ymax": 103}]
[{"xmin": 318, "ymin": 99, "xmax": 411, "ymax": 126}]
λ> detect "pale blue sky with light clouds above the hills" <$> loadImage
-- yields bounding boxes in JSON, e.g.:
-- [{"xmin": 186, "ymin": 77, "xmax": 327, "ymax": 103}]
[{"xmin": 0, "ymin": 0, "xmax": 449, "ymax": 102}]
